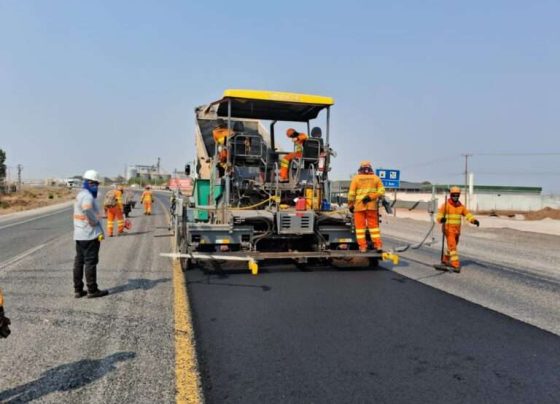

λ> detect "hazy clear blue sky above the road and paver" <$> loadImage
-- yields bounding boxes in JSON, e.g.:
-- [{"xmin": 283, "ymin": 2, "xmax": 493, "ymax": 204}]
[{"xmin": 0, "ymin": 0, "xmax": 560, "ymax": 193}]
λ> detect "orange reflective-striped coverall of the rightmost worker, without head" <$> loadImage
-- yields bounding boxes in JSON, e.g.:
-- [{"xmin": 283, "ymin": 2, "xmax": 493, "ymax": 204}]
[{"xmin": 436, "ymin": 198, "xmax": 476, "ymax": 268}]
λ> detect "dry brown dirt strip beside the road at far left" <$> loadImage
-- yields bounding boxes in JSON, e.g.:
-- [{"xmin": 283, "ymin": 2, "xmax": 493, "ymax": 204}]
[{"xmin": 0, "ymin": 187, "xmax": 75, "ymax": 215}]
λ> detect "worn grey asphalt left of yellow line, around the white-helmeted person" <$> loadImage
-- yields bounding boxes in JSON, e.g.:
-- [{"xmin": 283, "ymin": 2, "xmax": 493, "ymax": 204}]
[{"xmin": 0, "ymin": 196, "xmax": 176, "ymax": 403}]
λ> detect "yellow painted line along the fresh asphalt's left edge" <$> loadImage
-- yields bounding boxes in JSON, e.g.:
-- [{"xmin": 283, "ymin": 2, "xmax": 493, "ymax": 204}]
[{"xmin": 156, "ymin": 199, "xmax": 204, "ymax": 404}]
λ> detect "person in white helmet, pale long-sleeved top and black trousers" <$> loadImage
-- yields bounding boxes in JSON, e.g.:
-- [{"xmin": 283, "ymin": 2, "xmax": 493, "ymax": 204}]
[{"xmin": 74, "ymin": 170, "xmax": 109, "ymax": 298}]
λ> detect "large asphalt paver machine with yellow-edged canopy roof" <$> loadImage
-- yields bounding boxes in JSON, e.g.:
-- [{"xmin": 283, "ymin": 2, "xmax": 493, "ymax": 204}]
[{"xmin": 175, "ymin": 90, "xmax": 398, "ymax": 275}]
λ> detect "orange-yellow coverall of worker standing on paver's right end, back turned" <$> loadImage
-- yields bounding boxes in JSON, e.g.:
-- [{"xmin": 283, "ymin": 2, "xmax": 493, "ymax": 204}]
[{"xmin": 348, "ymin": 173, "xmax": 385, "ymax": 251}]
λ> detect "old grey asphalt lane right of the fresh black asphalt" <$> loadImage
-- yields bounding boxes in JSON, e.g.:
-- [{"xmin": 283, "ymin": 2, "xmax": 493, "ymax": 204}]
[{"xmin": 395, "ymin": 235, "xmax": 560, "ymax": 335}]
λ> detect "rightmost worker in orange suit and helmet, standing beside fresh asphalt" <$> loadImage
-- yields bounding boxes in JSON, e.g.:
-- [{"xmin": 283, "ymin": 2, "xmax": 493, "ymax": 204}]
[{"xmin": 436, "ymin": 187, "xmax": 480, "ymax": 272}]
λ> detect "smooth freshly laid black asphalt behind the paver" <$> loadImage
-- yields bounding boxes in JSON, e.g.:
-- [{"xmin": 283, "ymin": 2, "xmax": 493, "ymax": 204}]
[{"xmin": 187, "ymin": 254, "xmax": 560, "ymax": 403}]
